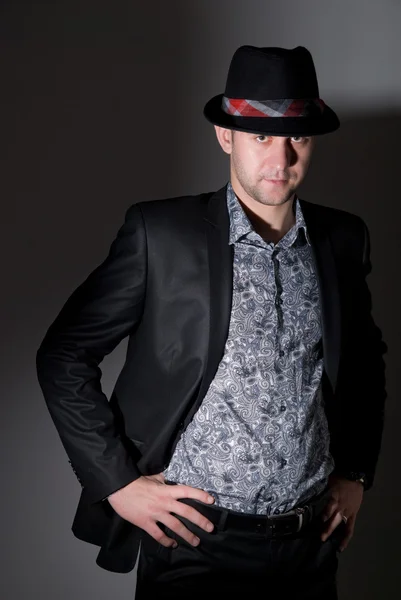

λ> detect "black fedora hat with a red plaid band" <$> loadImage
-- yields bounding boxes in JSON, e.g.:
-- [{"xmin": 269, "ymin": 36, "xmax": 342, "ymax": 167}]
[{"xmin": 203, "ymin": 46, "xmax": 340, "ymax": 136}]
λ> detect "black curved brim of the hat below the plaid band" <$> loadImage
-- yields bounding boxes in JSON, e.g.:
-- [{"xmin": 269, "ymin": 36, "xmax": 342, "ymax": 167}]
[{"xmin": 203, "ymin": 94, "xmax": 340, "ymax": 136}]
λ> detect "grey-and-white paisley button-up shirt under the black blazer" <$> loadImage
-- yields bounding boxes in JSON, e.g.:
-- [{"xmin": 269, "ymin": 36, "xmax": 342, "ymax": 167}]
[{"xmin": 163, "ymin": 183, "xmax": 334, "ymax": 515}]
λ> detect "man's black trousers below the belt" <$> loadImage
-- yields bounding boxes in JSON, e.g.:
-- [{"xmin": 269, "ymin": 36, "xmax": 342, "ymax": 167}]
[{"xmin": 135, "ymin": 496, "xmax": 345, "ymax": 600}]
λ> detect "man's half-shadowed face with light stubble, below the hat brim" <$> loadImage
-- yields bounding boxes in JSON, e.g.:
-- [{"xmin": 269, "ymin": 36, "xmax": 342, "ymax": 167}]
[{"xmin": 215, "ymin": 126, "xmax": 314, "ymax": 206}]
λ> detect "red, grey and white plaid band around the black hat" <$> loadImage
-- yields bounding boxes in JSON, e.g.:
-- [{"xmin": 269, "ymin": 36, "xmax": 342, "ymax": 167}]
[{"xmin": 221, "ymin": 96, "xmax": 325, "ymax": 117}]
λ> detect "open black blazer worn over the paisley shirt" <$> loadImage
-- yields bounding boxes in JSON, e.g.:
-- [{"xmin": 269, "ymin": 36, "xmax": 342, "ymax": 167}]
[{"xmin": 37, "ymin": 186, "xmax": 387, "ymax": 573}]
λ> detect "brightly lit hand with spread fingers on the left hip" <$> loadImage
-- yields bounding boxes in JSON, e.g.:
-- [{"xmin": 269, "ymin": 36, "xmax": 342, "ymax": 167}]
[{"xmin": 104, "ymin": 473, "xmax": 214, "ymax": 547}]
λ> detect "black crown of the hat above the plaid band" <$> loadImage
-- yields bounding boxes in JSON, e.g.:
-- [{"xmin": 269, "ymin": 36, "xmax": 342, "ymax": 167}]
[{"xmin": 225, "ymin": 46, "xmax": 319, "ymax": 100}]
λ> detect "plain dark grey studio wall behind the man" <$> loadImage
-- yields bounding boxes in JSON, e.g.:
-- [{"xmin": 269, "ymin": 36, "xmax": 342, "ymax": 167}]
[{"xmin": 0, "ymin": 0, "xmax": 401, "ymax": 600}]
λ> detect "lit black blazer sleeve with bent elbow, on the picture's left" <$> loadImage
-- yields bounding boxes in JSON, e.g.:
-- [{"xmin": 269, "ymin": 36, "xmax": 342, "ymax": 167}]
[{"xmin": 36, "ymin": 205, "xmax": 147, "ymax": 503}]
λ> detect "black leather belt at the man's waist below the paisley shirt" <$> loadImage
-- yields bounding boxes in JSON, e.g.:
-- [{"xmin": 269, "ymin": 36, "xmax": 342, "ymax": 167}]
[{"xmin": 166, "ymin": 481, "xmax": 329, "ymax": 538}]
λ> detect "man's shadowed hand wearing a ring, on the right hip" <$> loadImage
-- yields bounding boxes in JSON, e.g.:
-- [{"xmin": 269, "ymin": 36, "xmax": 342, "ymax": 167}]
[{"xmin": 321, "ymin": 475, "xmax": 364, "ymax": 551}]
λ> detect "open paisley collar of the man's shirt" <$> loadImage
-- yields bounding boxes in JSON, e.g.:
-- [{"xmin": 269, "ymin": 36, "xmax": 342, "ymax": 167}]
[{"xmin": 227, "ymin": 182, "xmax": 311, "ymax": 246}]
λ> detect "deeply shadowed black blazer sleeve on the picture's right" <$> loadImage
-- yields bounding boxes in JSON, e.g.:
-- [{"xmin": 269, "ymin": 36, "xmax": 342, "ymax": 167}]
[{"xmin": 335, "ymin": 219, "xmax": 388, "ymax": 489}]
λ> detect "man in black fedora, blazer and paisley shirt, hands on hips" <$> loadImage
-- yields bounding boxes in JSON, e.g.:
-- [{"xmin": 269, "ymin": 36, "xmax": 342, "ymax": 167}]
[{"xmin": 37, "ymin": 46, "xmax": 387, "ymax": 600}]
